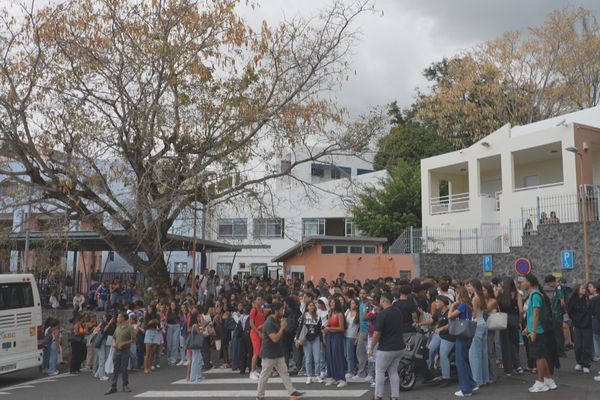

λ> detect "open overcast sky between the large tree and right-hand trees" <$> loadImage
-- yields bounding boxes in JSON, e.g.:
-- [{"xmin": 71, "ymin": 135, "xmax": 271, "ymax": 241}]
[{"xmin": 248, "ymin": 0, "xmax": 600, "ymax": 114}]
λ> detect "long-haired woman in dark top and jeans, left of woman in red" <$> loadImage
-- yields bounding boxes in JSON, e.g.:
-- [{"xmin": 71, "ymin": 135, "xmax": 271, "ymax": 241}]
[{"xmin": 296, "ymin": 301, "xmax": 323, "ymax": 385}]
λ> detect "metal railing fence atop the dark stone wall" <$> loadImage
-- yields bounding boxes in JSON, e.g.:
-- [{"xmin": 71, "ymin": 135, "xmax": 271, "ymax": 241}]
[{"xmin": 390, "ymin": 186, "xmax": 600, "ymax": 254}]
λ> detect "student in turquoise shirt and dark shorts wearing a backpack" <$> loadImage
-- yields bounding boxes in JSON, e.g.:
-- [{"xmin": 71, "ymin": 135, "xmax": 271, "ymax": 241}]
[{"xmin": 523, "ymin": 274, "xmax": 557, "ymax": 393}]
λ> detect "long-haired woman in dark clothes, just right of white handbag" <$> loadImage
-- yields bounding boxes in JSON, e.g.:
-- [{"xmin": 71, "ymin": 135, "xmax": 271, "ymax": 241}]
[{"xmin": 497, "ymin": 276, "xmax": 523, "ymax": 376}]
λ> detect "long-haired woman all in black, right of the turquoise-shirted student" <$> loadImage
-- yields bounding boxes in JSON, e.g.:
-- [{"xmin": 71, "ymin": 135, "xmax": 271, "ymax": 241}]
[{"xmin": 567, "ymin": 285, "xmax": 594, "ymax": 374}]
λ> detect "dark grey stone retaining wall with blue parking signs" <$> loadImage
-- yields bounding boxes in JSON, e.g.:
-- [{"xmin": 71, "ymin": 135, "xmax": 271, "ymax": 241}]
[{"xmin": 419, "ymin": 222, "xmax": 600, "ymax": 283}]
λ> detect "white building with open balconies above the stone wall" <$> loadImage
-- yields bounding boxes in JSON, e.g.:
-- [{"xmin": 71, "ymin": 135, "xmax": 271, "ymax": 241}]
[{"xmin": 421, "ymin": 106, "xmax": 600, "ymax": 251}]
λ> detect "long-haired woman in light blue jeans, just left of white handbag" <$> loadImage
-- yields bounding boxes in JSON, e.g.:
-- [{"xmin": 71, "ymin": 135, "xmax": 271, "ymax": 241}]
[{"xmin": 466, "ymin": 279, "xmax": 490, "ymax": 386}]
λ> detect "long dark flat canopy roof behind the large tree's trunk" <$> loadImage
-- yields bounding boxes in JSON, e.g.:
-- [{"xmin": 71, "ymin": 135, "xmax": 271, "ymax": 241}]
[{"xmin": 0, "ymin": 231, "xmax": 246, "ymax": 252}]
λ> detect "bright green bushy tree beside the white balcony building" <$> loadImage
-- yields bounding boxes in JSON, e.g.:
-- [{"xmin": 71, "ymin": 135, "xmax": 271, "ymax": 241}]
[{"xmin": 352, "ymin": 159, "xmax": 421, "ymax": 243}]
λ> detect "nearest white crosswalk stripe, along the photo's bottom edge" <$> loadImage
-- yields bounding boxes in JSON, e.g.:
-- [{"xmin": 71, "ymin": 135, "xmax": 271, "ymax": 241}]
[{"xmin": 135, "ymin": 390, "xmax": 368, "ymax": 399}]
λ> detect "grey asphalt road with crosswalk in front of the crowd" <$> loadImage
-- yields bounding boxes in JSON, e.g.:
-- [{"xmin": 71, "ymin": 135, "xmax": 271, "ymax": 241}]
[{"xmin": 0, "ymin": 352, "xmax": 600, "ymax": 400}]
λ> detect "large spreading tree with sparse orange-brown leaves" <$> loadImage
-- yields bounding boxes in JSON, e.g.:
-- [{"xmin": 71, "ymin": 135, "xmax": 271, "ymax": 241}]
[{"xmin": 0, "ymin": 0, "xmax": 377, "ymax": 280}]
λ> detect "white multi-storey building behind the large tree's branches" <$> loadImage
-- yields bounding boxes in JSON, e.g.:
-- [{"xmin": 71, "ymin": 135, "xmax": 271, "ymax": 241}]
[{"xmin": 206, "ymin": 148, "xmax": 387, "ymax": 276}]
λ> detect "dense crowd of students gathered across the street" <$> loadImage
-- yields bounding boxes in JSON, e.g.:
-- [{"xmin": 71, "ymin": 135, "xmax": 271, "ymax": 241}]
[{"xmin": 44, "ymin": 271, "xmax": 600, "ymax": 399}]
